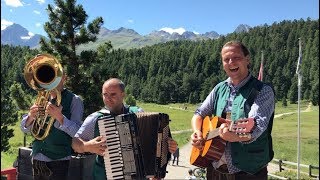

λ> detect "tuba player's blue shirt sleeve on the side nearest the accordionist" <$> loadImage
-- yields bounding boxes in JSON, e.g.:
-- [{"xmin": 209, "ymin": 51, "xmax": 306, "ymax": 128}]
[{"xmin": 55, "ymin": 95, "xmax": 83, "ymax": 137}]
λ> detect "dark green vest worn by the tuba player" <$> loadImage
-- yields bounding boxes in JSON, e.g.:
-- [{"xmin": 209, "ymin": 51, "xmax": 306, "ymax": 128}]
[{"xmin": 32, "ymin": 89, "xmax": 74, "ymax": 160}]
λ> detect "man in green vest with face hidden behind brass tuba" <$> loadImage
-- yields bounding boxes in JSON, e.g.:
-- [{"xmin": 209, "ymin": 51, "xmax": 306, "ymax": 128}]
[{"xmin": 21, "ymin": 55, "xmax": 83, "ymax": 180}]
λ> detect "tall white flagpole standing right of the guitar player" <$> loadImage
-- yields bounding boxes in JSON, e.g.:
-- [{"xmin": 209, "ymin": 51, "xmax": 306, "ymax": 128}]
[{"xmin": 296, "ymin": 38, "xmax": 302, "ymax": 179}]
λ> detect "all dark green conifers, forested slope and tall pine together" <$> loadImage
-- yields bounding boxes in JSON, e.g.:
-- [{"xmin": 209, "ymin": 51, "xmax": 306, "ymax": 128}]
[{"xmin": 1, "ymin": 0, "xmax": 319, "ymax": 151}]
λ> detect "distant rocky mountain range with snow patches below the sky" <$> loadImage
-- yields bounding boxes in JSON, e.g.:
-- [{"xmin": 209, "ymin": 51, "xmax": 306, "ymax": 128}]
[{"xmin": 1, "ymin": 24, "xmax": 251, "ymax": 51}]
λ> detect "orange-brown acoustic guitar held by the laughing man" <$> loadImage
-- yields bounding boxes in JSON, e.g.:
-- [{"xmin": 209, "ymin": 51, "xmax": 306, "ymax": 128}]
[{"xmin": 190, "ymin": 116, "xmax": 254, "ymax": 168}]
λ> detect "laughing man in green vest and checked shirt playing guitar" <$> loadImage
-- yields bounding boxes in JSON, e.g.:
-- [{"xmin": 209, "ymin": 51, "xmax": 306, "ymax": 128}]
[{"xmin": 191, "ymin": 41, "xmax": 275, "ymax": 180}]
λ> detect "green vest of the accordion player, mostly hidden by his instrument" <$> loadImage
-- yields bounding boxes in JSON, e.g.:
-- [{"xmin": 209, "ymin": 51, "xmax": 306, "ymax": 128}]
[{"xmin": 93, "ymin": 106, "xmax": 137, "ymax": 180}]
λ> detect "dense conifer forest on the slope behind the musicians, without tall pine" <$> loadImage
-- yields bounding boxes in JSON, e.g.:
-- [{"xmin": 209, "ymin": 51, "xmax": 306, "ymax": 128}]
[{"xmin": 1, "ymin": 20, "xmax": 319, "ymax": 109}]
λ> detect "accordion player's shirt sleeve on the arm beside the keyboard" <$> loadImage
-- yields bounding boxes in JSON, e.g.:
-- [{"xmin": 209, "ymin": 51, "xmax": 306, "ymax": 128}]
[{"xmin": 74, "ymin": 112, "xmax": 99, "ymax": 141}]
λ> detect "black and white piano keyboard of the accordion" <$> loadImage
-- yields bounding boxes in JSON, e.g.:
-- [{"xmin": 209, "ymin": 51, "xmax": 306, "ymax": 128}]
[{"xmin": 98, "ymin": 116, "xmax": 136, "ymax": 179}]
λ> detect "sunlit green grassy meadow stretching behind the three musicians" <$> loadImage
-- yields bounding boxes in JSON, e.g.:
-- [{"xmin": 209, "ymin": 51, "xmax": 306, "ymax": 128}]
[{"xmin": 1, "ymin": 102, "xmax": 319, "ymax": 177}]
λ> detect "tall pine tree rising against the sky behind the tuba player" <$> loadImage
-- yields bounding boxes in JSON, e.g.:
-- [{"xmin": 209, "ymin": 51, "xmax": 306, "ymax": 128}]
[{"xmin": 40, "ymin": 0, "xmax": 103, "ymax": 114}]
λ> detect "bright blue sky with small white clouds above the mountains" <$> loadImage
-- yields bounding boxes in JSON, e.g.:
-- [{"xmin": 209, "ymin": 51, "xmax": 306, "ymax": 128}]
[{"xmin": 1, "ymin": 0, "xmax": 319, "ymax": 35}]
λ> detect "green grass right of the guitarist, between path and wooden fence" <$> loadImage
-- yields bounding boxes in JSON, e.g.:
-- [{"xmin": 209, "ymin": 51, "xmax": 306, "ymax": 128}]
[{"xmin": 272, "ymin": 111, "xmax": 319, "ymax": 165}]
